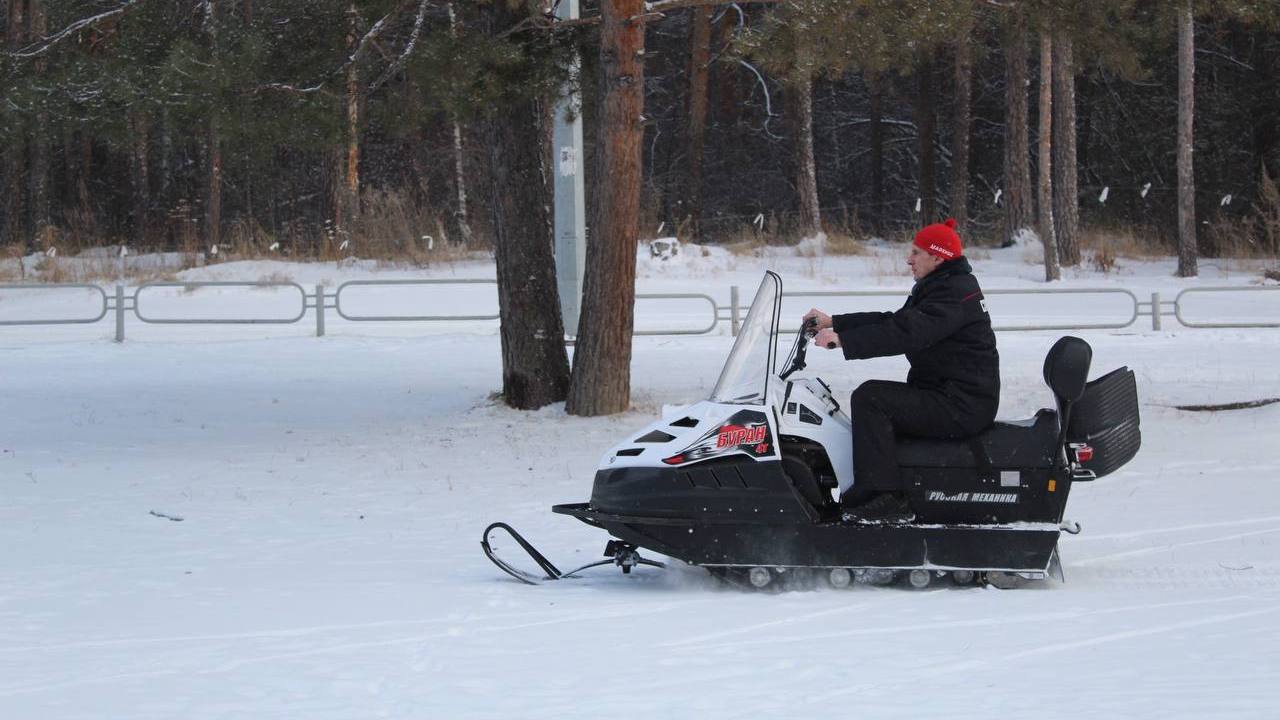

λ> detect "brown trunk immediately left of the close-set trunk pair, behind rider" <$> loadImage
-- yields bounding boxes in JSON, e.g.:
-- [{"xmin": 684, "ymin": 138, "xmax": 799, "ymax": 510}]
[{"xmin": 1004, "ymin": 10, "xmax": 1034, "ymax": 246}]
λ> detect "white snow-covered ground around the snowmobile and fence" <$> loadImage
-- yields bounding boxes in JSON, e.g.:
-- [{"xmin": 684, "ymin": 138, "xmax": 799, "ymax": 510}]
[{"xmin": 0, "ymin": 242, "xmax": 1280, "ymax": 720}]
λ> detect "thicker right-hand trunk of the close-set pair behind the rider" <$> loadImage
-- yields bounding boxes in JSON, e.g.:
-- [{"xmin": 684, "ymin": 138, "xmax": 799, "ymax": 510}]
[{"xmin": 1053, "ymin": 32, "xmax": 1080, "ymax": 265}]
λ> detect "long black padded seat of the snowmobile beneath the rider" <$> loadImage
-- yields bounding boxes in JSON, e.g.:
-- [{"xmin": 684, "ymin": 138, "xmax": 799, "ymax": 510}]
[{"xmin": 897, "ymin": 410, "xmax": 1060, "ymax": 468}]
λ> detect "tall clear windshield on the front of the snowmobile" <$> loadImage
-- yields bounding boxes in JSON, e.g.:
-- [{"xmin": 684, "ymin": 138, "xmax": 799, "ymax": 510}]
[{"xmin": 710, "ymin": 273, "xmax": 782, "ymax": 405}]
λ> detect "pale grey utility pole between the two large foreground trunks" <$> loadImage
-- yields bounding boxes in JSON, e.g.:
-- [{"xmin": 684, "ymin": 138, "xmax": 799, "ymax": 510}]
[{"xmin": 552, "ymin": 0, "xmax": 586, "ymax": 337}]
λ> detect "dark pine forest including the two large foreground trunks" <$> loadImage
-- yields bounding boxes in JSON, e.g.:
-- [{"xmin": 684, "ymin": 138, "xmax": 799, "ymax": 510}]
[{"xmin": 0, "ymin": 0, "xmax": 1280, "ymax": 414}]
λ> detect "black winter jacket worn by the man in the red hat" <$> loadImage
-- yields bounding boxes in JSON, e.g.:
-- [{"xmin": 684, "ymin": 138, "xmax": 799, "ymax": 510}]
[{"xmin": 832, "ymin": 256, "xmax": 1000, "ymax": 427}]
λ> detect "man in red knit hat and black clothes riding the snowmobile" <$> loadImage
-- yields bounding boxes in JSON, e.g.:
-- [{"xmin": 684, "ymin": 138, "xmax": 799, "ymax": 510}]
[{"xmin": 804, "ymin": 218, "xmax": 1000, "ymax": 521}]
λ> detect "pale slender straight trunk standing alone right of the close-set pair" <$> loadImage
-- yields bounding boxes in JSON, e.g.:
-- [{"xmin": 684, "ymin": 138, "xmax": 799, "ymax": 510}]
[{"xmin": 1178, "ymin": 0, "xmax": 1199, "ymax": 278}]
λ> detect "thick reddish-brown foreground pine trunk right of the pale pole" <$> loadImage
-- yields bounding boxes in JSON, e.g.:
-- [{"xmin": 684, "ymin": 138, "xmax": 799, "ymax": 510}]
[{"xmin": 568, "ymin": 0, "xmax": 645, "ymax": 415}]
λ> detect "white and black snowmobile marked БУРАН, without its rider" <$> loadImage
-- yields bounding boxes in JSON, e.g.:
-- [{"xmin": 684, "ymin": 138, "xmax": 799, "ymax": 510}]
[{"xmin": 483, "ymin": 272, "xmax": 1142, "ymax": 588}]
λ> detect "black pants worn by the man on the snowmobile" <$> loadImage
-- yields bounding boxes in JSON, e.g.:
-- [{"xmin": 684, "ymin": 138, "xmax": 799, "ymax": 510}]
[{"xmin": 849, "ymin": 380, "xmax": 992, "ymax": 500}]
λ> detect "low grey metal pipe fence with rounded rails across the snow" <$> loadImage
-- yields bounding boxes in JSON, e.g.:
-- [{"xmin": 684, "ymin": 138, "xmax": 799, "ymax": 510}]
[{"xmin": 0, "ymin": 278, "xmax": 1280, "ymax": 342}]
